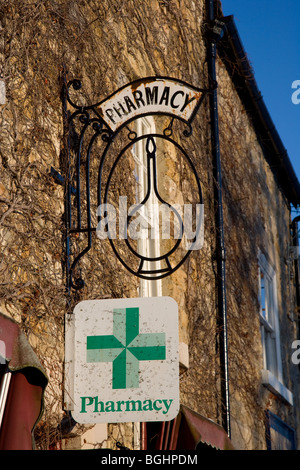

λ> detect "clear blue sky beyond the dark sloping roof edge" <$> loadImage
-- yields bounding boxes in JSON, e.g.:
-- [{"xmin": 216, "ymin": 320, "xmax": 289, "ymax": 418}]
[{"xmin": 221, "ymin": 0, "xmax": 300, "ymax": 185}]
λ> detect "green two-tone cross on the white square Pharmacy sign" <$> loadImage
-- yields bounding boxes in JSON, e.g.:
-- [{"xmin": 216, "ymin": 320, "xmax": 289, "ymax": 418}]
[{"xmin": 87, "ymin": 308, "xmax": 166, "ymax": 389}]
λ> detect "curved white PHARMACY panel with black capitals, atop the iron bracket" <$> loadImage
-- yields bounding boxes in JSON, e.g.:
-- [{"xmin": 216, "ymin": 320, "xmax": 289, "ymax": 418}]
[{"xmin": 98, "ymin": 77, "xmax": 204, "ymax": 131}]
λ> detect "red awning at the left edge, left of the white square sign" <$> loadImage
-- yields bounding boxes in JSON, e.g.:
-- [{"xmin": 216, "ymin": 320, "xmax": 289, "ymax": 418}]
[{"xmin": 0, "ymin": 313, "xmax": 48, "ymax": 450}]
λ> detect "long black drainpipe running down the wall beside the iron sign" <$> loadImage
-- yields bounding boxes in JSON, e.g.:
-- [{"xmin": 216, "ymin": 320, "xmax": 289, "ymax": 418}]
[{"xmin": 207, "ymin": 0, "xmax": 231, "ymax": 438}]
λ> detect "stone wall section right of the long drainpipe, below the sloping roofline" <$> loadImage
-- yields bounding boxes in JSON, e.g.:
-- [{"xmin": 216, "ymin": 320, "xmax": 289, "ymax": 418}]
[{"xmin": 218, "ymin": 57, "xmax": 299, "ymax": 449}]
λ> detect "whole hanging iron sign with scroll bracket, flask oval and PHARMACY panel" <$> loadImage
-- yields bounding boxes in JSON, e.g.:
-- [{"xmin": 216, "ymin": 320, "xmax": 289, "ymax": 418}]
[{"xmin": 64, "ymin": 77, "xmax": 208, "ymax": 290}]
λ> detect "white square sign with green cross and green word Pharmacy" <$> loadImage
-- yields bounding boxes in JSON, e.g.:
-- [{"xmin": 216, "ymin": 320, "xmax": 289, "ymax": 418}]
[{"xmin": 66, "ymin": 297, "xmax": 179, "ymax": 424}]
